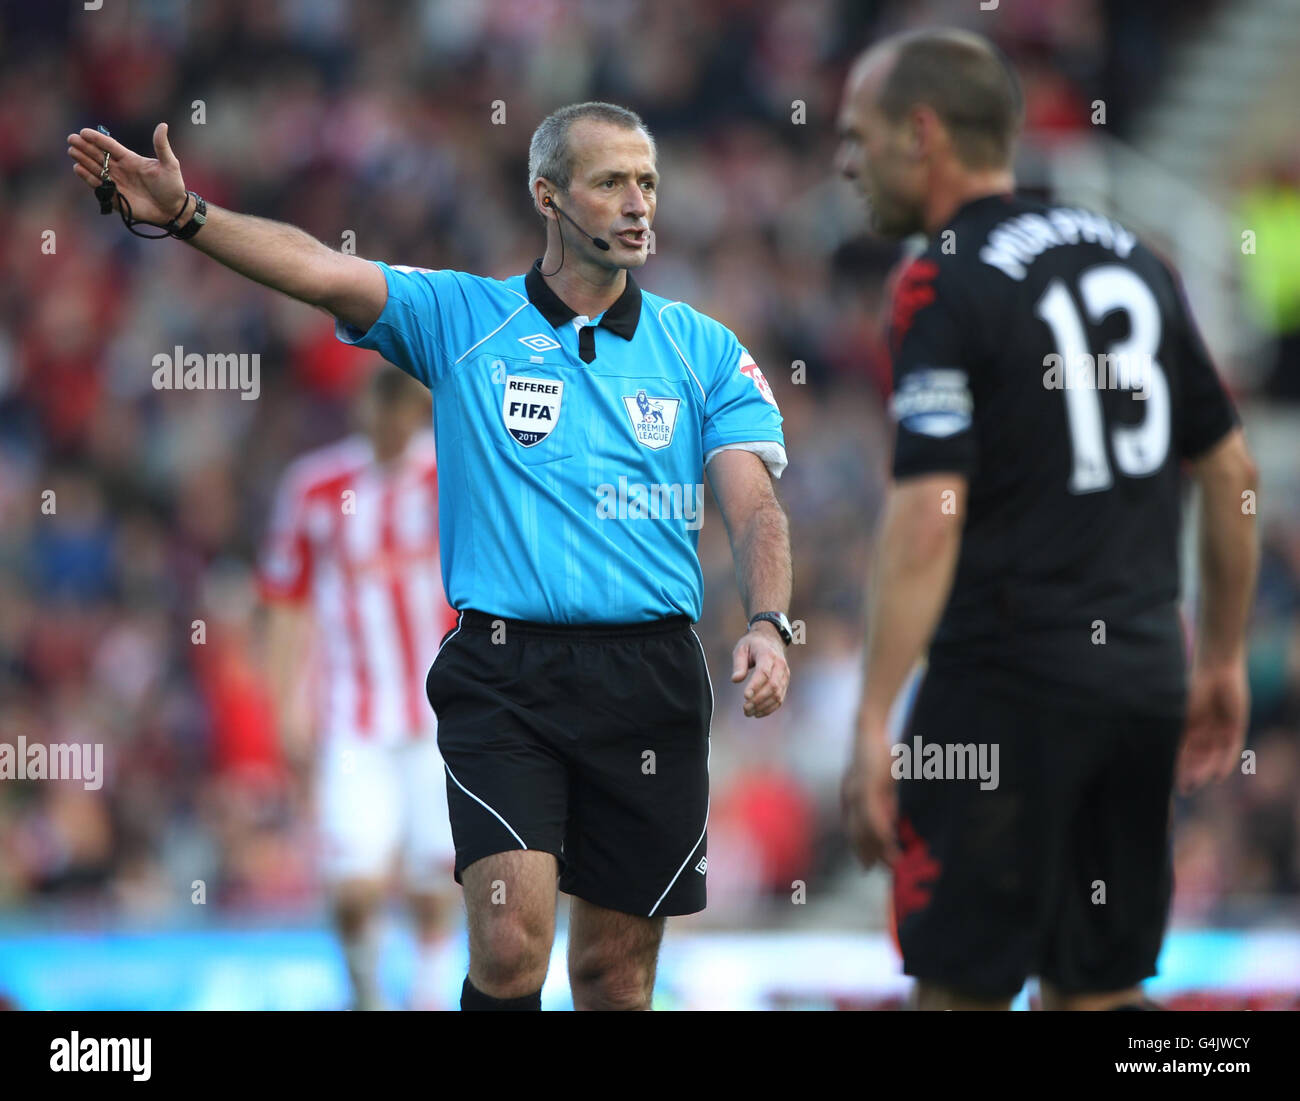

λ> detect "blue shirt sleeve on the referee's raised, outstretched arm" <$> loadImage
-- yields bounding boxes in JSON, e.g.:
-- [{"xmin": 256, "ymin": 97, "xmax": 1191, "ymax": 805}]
[{"xmin": 334, "ymin": 260, "xmax": 462, "ymax": 390}]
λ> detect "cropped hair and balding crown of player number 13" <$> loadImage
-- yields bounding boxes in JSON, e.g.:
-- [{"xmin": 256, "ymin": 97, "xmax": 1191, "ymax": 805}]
[{"xmin": 845, "ymin": 27, "xmax": 1024, "ymax": 169}]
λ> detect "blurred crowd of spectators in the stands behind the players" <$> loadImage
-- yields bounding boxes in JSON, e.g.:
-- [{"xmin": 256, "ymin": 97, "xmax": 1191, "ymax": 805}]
[{"xmin": 0, "ymin": 0, "xmax": 1300, "ymax": 923}]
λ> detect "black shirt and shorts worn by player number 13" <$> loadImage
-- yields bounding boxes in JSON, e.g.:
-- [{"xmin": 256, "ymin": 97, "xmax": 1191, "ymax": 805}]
[{"xmin": 891, "ymin": 195, "xmax": 1236, "ymax": 997}]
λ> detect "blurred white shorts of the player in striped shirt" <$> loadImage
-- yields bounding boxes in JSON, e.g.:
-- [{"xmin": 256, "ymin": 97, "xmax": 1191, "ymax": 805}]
[{"xmin": 316, "ymin": 734, "xmax": 456, "ymax": 890}]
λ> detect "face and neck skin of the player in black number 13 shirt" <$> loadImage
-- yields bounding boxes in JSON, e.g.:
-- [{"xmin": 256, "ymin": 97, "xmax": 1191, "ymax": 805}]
[{"xmin": 835, "ymin": 55, "xmax": 926, "ymax": 237}]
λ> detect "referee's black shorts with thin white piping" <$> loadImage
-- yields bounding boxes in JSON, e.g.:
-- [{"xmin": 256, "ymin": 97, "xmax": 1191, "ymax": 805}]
[{"xmin": 425, "ymin": 611, "xmax": 712, "ymax": 916}]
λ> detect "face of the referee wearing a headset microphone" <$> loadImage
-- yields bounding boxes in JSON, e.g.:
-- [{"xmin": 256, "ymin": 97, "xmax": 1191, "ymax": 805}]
[{"xmin": 564, "ymin": 118, "xmax": 659, "ymax": 268}]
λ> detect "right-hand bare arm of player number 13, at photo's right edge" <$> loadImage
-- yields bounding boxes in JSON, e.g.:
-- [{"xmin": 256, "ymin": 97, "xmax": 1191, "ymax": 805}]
[{"xmin": 1178, "ymin": 428, "xmax": 1260, "ymax": 794}]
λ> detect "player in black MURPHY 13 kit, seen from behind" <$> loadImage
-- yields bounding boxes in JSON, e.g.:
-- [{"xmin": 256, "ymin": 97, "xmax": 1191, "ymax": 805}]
[{"xmin": 839, "ymin": 31, "xmax": 1257, "ymax": 1009}]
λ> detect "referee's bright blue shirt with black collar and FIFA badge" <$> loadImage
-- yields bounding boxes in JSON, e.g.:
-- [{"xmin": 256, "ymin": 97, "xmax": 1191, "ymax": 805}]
[{"xmin": 335, "ymin": 253, "xmax": 785, "ymax": 624}]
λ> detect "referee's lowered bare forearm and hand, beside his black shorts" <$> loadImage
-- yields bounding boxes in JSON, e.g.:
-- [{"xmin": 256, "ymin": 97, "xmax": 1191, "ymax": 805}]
[{"xmin": 709, "ymin": 451, "xmax": 793, "ymax": 719}]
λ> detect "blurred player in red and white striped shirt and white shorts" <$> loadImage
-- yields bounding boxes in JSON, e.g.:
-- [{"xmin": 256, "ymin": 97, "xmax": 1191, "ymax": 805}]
[{"xmin": 261, "ymin": 365, "xmax": 455, "ymax": 1009}]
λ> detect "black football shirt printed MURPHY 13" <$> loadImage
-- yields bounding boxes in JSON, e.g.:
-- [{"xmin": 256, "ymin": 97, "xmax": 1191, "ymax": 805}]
[{"xmin": 889, "ymin": 195, "xmax": 1236, "ymax": 715}]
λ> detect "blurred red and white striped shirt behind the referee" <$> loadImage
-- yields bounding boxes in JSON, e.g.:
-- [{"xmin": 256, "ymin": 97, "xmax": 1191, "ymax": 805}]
[{"xmin": 260, "ymin": 432, "xmax": 456, "ymax": 744}]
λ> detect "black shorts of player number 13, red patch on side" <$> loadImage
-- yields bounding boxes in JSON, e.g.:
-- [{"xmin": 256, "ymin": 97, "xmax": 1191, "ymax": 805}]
[{"xmin": 893, "ymin": 672, "xmax": 1183, "ymax": 1000}]
